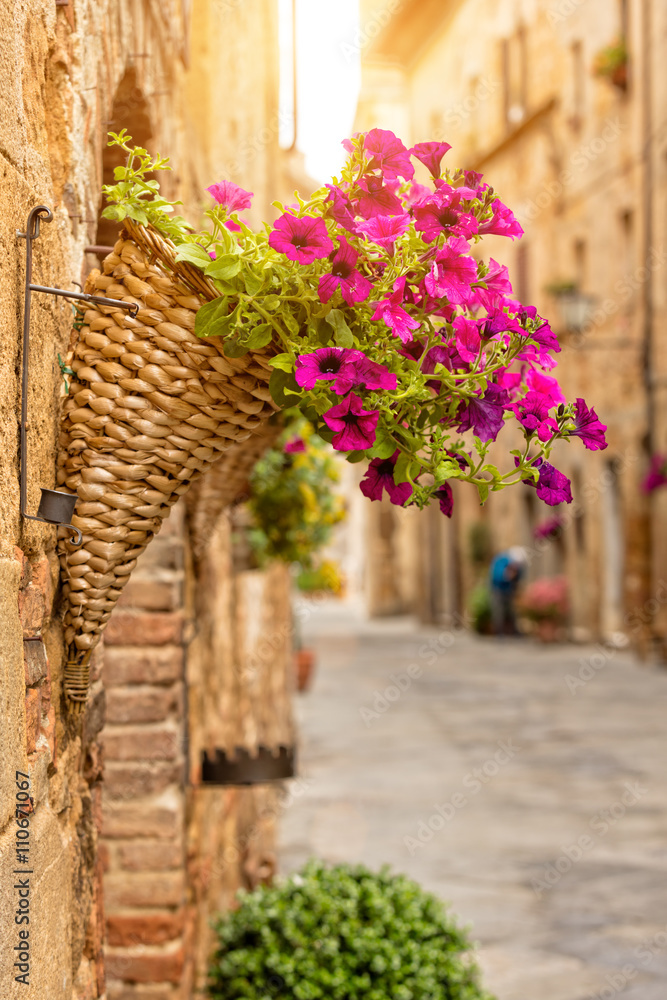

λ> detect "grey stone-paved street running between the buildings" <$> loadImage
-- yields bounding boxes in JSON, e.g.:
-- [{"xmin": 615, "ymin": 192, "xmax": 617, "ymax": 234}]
[{"xmin": 280, "ymin": 603, "xmax": 667, "ymax": 1000}]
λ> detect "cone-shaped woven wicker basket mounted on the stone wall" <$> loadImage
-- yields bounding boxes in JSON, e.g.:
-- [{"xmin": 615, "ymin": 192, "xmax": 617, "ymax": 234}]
[{"xmin": 58, "ymin": 222, "xmax": 276, "ymax": 704}]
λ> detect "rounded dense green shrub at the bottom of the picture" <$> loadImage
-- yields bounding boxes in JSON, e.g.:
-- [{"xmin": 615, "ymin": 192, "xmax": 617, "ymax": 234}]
[{"xmin": 209, "ymin": 861, "xmax": 492, "ymax": 1000}]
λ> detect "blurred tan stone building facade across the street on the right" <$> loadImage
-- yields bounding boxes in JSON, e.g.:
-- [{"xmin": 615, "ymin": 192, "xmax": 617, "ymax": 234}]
[{"xmin": 356, "ymin": 0, "xmax": 667, "ymax": 654}]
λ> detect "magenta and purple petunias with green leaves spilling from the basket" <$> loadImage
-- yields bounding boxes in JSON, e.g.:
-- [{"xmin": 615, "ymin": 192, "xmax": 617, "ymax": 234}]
[{"xmin": 102, "ymin": 129, "xmax": 606, "ymax": 516}]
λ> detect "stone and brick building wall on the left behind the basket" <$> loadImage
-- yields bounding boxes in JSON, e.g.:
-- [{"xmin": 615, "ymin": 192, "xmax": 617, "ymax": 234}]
[{"xmin": 0, "ymin": 0, "xmax": 295, "ymax": 1000}]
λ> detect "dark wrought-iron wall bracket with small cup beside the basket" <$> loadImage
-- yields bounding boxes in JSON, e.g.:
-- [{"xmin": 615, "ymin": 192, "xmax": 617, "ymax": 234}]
[{"xmin": 16, "ymin": 205, "xmax": 139, "ymax": 545}]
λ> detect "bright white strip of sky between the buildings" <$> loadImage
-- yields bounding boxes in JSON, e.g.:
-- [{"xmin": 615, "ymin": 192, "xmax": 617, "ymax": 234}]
[{"xmin": 279, "ymin": 0, "xmax": 361, "ymax": 182}]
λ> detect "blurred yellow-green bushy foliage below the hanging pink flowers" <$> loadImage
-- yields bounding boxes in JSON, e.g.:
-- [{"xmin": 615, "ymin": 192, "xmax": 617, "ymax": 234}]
[{"xmin": 248, "ymin": 418, "xmax": 344, "ymax": 570}]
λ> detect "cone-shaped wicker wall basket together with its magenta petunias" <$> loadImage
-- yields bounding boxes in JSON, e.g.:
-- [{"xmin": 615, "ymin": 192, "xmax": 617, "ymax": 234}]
[{"xmin": 59, "ymin": 129, "xmax": 606, "ymax": 704}]
